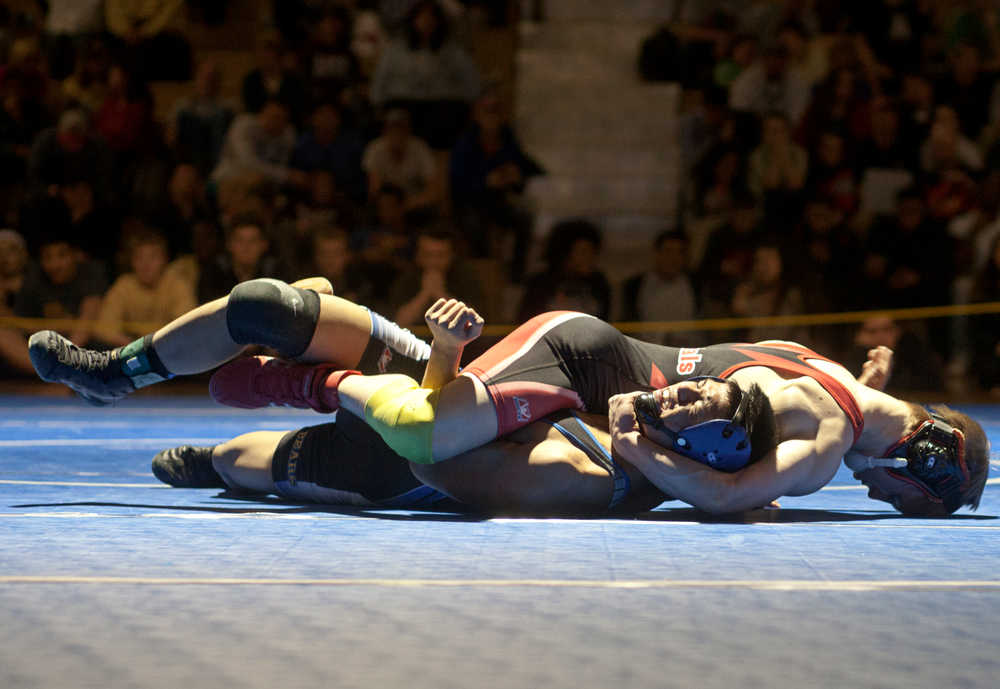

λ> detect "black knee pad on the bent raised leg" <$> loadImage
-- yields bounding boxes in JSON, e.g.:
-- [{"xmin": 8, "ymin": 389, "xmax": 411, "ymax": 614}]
[{"xmin": 226, "ymin": 278, "xmax": 319, "ymax": 358}]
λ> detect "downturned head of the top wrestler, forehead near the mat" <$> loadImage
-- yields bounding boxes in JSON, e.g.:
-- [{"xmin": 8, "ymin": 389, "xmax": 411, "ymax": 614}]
[{"xmin": 854, "ymin": 404, "xmax": 990, "ymax": 517}]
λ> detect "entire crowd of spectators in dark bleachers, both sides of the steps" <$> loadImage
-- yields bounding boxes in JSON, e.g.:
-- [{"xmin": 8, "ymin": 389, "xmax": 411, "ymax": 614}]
[{"xmin": 0, "ymin": 0, "xmax": 1000, "ymax": 392}]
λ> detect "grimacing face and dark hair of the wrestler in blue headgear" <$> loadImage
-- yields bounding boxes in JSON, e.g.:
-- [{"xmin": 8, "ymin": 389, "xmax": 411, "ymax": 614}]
[{"xmin": 640, "ymin": 378, "xmax": 777, "ymax": 471}]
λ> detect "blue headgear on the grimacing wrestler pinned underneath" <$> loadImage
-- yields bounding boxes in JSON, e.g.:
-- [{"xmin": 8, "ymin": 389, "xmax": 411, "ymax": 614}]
[{"xmin": 632, "ymin": 376, "xmax": 751, "ymax": 472}]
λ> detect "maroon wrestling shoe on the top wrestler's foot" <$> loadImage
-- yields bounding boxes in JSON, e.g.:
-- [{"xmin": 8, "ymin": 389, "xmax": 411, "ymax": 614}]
[{"xmin": 208, "ymin": 356, "xmax": 357, "ymax": 414}]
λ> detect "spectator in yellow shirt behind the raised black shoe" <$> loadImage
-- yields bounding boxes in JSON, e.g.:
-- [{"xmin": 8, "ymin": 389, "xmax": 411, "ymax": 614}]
[{"xmin": 98, "ymin": 232, "xmax": 197, "ymax": 347}]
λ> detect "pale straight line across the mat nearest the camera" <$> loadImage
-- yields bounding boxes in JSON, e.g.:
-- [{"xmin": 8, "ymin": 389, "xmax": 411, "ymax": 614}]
[{"xmin": 0, "ymin": 575, "xmax": 1000, "ymax": 593}]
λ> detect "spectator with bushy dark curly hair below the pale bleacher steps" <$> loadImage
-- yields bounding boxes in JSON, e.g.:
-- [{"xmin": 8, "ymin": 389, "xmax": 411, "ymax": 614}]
[{"xmin": 517, "ymin": 220, "xmax": 611, "ymax": 322}]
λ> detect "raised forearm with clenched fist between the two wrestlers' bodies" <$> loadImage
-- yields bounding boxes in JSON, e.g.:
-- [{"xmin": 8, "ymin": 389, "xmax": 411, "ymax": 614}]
[{"xmin": 420, "ymin": 299, "xmax": 483, "ymax": 390}]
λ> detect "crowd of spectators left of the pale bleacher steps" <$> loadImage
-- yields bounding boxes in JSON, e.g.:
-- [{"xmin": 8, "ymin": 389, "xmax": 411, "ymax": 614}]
[{"xmin": 0, "ymin": 0, "xmax": 541, "ymax": 375}]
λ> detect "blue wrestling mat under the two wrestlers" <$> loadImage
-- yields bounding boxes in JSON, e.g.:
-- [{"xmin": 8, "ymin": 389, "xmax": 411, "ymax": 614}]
[{"xmin": 0, "ymin": 397, "xmax": 1000, "ymax": 689}]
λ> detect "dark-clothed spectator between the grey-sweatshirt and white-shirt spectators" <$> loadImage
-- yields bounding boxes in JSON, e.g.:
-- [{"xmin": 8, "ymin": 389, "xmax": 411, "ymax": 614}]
[{"xmin": 291, "ymin": 102, "xmax": 367, "ymax": 202}]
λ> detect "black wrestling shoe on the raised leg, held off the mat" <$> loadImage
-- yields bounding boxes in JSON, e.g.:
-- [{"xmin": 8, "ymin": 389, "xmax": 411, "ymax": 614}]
[{"xmin": 28, "ymin": 330, "xmax": 135, "ymax": 407}]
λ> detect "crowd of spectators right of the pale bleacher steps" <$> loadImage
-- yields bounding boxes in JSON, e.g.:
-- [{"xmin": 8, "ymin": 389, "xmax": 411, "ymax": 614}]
[{"xmin": 626, "ymin": 0, "xmax": 1000, "ymax": 392}]
